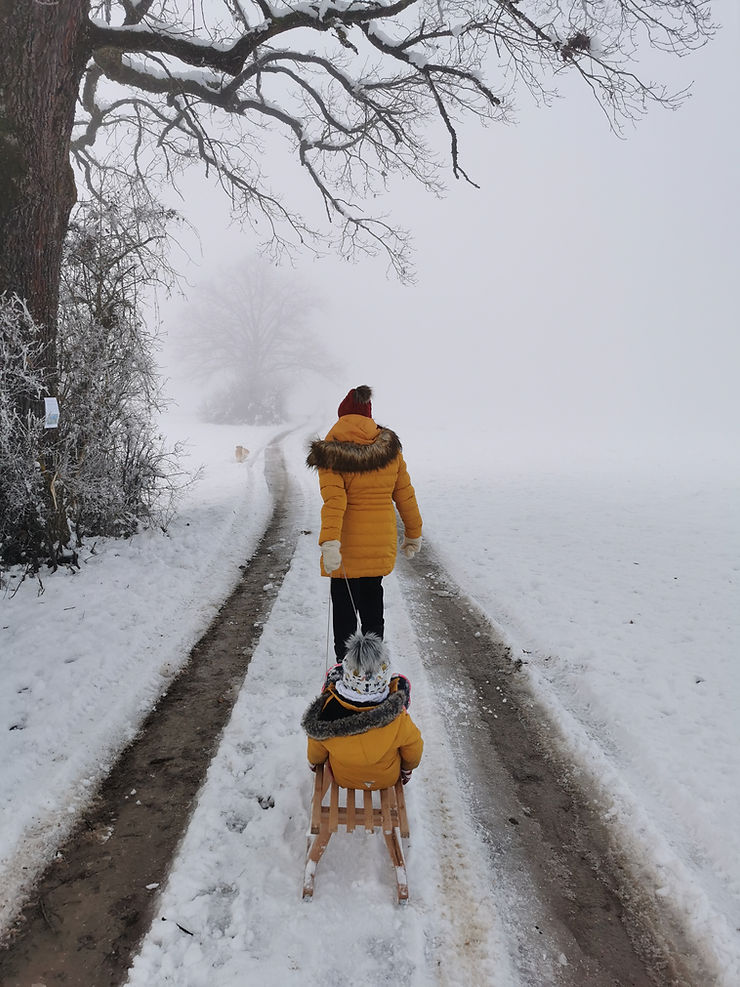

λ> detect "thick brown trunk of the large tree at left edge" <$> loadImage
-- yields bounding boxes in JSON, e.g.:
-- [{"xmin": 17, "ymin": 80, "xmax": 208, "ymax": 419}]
[{"xmin": 0, "ymin": 0, "xmax": 89, "ymax": 558}]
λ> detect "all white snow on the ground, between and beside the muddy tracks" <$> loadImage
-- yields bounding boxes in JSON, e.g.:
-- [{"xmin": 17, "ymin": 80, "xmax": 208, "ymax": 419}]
[{"xmin": 0, "ymin": 412, "xmax": 740, "ymax": 987}]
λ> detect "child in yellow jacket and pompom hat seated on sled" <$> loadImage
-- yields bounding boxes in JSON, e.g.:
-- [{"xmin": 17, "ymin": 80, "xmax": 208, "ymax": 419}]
[{"xmin": 301, "ymin": 632, "xmax": 424, "ymax": 790}]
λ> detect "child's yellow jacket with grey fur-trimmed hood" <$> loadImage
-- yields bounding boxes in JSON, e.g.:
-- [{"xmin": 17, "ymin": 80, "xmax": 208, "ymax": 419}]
[{"xmin": 302, "ymin": 680, "xmax": 424, "ymax": 790}]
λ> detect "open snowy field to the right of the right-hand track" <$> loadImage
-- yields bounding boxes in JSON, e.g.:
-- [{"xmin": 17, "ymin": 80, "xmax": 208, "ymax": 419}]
[{"xmin": 404, "ymin": 422, "xmax": 740, "ymax": 985}]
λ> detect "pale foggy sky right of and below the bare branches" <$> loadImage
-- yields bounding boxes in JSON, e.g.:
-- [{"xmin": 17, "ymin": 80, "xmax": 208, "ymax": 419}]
[{"xmin": 158, "ymin": 4, "xmax": 740, "ymax": 450}]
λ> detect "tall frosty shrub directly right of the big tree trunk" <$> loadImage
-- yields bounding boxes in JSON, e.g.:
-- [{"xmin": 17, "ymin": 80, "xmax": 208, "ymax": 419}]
[{"xmin": 58, "ymin": 198, "xmax": 182, "ymax": 540}]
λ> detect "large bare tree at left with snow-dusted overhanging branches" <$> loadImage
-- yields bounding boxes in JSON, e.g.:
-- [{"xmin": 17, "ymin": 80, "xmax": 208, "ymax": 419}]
[{"xmin": 0, "ymin": 0, "xmax": 712, "ymax": 556}]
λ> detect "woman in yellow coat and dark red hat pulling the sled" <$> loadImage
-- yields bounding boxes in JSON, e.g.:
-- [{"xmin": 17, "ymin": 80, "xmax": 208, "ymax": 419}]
[{"xmin": 306, "ymin": 385, "xmax": 422, "ymax": 661}]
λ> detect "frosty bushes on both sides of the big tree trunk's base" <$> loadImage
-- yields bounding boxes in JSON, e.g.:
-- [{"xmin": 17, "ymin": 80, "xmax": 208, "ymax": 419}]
[{"xmin": 0, "ymin": 191, "xmax": 188, "ymax": 568}]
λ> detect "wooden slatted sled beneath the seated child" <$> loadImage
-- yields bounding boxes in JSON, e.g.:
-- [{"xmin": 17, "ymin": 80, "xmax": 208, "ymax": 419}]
[{"xmin": 303, "ymin": 763, "xmax": 409, "ymax": 904}]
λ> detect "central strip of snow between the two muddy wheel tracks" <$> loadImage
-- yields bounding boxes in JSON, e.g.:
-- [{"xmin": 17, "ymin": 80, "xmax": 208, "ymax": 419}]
[{"xmin": 129, "ymin": 438, "xmax": 515, "ymax": 987}]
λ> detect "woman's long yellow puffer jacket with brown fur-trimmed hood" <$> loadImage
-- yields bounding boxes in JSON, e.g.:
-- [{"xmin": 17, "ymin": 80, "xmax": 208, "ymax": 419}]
[{"xmin": 306, "ymin": 415, "xmax": 421, "ymax": 579}]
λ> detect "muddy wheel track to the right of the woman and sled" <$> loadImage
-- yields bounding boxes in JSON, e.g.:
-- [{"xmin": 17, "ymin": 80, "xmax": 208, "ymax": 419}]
[{"xmin": 397, "ymin": 552, "xmax": 715, "ymax": 987}]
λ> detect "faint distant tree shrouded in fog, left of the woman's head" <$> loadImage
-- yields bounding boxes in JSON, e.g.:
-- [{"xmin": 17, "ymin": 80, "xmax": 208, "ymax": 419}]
[{"xmin": 178, "ymin": 258, "xmax": 331, "ymax": 425}]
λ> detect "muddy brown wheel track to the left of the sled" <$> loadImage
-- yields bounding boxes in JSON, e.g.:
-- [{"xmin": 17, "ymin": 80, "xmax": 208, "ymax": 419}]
[{"xmin": 0, "ymin": 436, "xmax": 298, "ymax": 987}]
